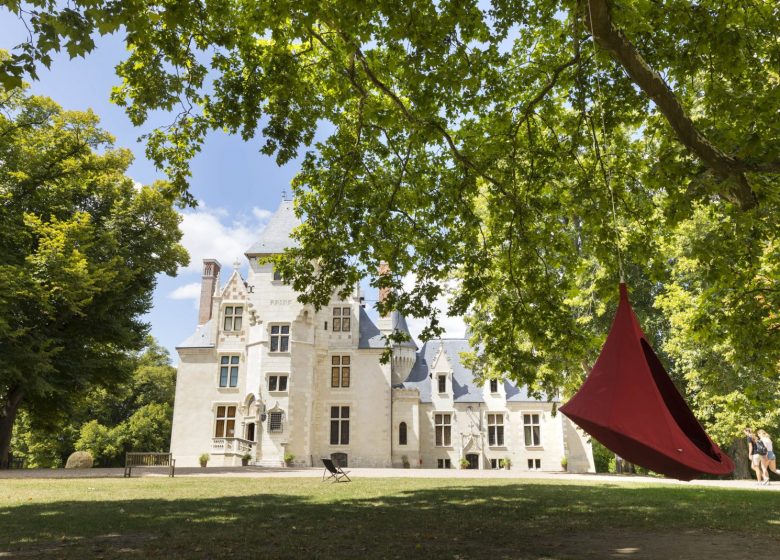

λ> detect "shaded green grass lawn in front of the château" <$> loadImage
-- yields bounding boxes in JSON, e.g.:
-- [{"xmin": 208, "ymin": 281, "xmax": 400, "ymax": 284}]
[{"xmin": 0, "ymin": 478, "xmax": 780, "ymax": 560}]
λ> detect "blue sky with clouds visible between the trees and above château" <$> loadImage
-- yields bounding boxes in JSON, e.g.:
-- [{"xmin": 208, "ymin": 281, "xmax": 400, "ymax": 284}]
[{"xmin": 0, "ymin": 15, "xmax": 463, "ymax": 363}]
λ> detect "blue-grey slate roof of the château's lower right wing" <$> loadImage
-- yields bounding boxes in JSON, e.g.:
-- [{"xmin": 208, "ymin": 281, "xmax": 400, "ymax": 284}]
[{"xmin": 402, "ymin": 338, "xmax": 552, "ymax": 403}]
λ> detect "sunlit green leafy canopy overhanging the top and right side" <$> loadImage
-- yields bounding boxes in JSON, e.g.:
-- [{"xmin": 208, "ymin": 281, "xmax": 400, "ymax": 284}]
[{"xmin": 2, "ymin": 0, "xmax": 780, "ymax": 446}]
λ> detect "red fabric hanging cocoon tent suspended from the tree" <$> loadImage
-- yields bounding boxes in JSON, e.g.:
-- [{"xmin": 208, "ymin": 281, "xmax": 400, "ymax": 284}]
[{"xmin": 560, "ymin": 284, "xmax": 734, "ymax": 480}]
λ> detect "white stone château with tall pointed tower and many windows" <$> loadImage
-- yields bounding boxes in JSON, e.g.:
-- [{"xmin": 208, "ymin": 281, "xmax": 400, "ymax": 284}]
[{"xmin": 171, "ymin": 201, "xmax": 593, "ymax": 472}]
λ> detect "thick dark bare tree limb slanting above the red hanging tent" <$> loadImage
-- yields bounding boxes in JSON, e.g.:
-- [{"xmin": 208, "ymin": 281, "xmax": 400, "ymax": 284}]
[{"xmin": 586, "ymin": 0, "xmax": 768, "ymax": 210}]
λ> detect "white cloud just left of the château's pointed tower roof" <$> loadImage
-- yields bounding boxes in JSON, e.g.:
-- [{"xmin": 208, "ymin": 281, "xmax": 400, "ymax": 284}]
[{"xmin": 180, "ymin": 202, "xmax": 271, "ymax": 273}]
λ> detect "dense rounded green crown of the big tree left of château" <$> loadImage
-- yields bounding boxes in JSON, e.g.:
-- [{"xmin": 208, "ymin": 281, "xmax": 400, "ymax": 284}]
[{"xmin": 0, "ymin": 86, "xmax": 188, "ymax": 463}]
